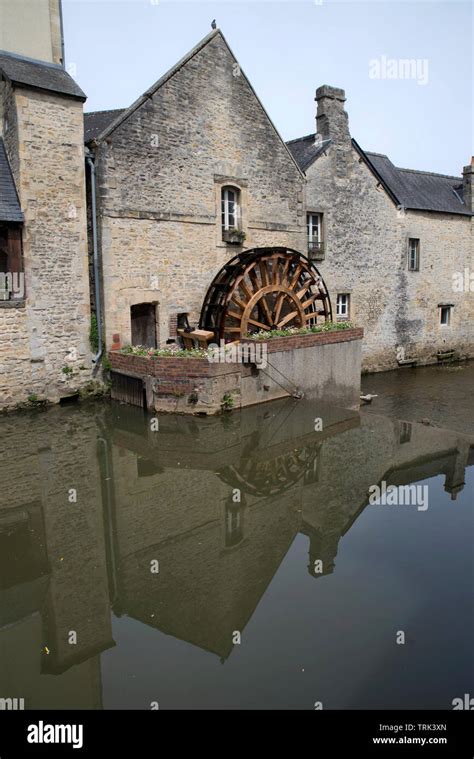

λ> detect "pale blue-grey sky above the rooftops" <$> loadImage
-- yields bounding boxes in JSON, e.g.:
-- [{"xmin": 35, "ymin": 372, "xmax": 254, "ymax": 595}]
[{"xmin": 63, "ymin": 0, "xmax": 474, "ymax": 176}]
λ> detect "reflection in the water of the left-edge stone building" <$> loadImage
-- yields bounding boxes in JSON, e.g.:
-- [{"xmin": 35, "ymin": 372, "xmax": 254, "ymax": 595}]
[{"xmin": 0, "ymin": 409, "xmax": 112, "ymax": 709}]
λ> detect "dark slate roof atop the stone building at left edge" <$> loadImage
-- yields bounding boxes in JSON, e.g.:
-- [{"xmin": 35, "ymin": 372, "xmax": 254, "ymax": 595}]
[{"xmin": 0, "ymin": 53, "xmax": 86, "ymax": 100}]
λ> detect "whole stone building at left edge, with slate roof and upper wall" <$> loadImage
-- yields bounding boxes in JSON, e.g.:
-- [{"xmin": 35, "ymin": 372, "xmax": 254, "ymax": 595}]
[{"xmin": 0, "ymin": 0, "xmax": 92, "ymax": 408}]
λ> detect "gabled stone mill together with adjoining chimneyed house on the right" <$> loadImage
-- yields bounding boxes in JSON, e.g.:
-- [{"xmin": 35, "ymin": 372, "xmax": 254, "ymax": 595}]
[{"xmin": 85, "ymin": 30, "xmax": 474, "ymax": 371}]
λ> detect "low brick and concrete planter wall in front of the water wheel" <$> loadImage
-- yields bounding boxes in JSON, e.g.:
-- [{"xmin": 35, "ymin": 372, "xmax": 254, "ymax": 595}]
[{"xmin": 108, "ymin": 328, "xmax": 363, "ymax": 413}]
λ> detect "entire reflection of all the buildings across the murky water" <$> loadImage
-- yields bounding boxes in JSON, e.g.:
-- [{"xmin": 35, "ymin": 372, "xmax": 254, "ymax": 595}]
[{"xmin": 0, "ymin": 400, "xmax": 474, "ymax": 708}]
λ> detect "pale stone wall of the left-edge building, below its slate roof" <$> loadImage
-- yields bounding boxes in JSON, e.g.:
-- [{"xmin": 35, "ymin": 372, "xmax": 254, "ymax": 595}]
[{"xmin": 0, "ymin": 86, "xmax": 91, "ymax": 408}]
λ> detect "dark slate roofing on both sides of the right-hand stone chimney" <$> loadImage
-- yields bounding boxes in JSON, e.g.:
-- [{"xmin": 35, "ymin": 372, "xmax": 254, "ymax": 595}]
[{"xmin": 287, "ymin": 134, "xmax": 472, "ymax": 216}]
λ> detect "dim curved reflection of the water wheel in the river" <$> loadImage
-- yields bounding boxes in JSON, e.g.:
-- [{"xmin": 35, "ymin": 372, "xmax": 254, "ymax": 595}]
[{"xmin": 219, "ymin": 443, "xmax": 321, "ymax": 496}]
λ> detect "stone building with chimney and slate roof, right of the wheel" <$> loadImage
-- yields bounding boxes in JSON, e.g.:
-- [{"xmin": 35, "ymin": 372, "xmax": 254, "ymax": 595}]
[{"xmin": 288, "ymin": 86, "xmax": 474, "ymax": 371}]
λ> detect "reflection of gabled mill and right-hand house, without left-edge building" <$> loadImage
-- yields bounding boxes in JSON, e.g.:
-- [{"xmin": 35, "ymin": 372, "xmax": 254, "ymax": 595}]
[{"xmin": 105, "ymin": 401, "xmax": 469, "ymax": 658}]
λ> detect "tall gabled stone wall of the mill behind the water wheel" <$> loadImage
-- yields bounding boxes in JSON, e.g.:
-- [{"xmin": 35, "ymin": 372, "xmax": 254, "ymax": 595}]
[{"xmin": 96, "ymin": 33, "xmax": 305, "ymax": 347}]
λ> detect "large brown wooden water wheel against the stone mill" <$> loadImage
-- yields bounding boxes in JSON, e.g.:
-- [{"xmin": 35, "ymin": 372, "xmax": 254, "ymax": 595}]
[{"xmin": 199, "ymin": 248, "xmax": 332, "ymax": 340}]
